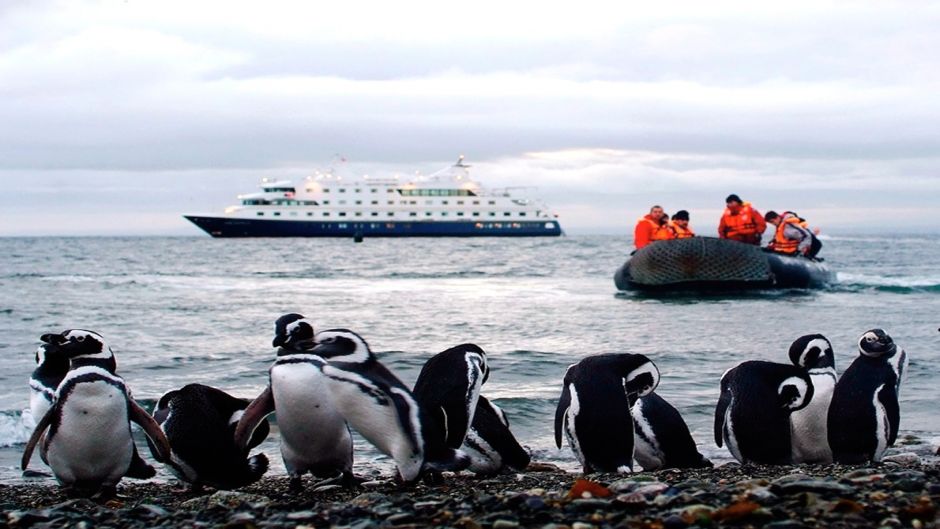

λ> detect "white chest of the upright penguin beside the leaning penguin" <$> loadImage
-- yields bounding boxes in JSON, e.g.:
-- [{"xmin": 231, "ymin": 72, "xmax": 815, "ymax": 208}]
[{"xmin": 271, "ymin": 363, "xmax": 348, "ymax": 449}]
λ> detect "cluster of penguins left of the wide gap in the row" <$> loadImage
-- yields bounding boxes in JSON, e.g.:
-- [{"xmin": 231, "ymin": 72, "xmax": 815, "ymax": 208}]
[{"xmin": 22, "ymin": 313, "xmax": 530, "ymax": 496}]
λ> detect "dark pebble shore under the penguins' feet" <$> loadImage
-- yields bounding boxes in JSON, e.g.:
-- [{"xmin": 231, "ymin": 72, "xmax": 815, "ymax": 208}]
[{"xmin": 0, "ymin": 456, "xmax": 940, "ymax": 529}]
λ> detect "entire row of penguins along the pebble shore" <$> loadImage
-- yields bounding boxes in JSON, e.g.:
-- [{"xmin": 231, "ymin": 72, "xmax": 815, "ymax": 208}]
[{"xmin": 22, "ymin": 313, "xmax": 907, "ymax": 496}]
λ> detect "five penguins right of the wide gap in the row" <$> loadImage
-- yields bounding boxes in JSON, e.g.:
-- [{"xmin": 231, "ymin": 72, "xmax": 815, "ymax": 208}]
[{"xmin": 555, "ymin": 329, "xmax": 908, "ymax": 473}]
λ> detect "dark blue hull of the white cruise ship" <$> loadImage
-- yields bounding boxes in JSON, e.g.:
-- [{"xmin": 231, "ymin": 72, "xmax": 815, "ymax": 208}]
[{"xmin": 185, "ymin": 215, "xmax": 561, "ymax": 237}]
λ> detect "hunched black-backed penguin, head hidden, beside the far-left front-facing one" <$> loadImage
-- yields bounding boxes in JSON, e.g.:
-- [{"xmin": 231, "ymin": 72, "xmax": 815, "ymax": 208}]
[{"xmin": 151, "ymin": 384, "xmax": 270, "ymax": 490}]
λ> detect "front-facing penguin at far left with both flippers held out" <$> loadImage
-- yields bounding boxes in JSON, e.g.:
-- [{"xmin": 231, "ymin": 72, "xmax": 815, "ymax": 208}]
[{"xmin": 21, "ymin": 329, "xmax": 170, "ymax": 497}]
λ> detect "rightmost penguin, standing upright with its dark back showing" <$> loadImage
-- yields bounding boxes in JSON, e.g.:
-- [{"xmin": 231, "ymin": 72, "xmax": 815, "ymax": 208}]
[{"xmin": 829, "ymin": 329, "xmax": 908, "ymax": 464}]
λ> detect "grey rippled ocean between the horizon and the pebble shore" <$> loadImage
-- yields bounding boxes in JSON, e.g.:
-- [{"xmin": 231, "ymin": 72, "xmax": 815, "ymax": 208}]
[{"xmin": 0, "ymin": 234, "xmax": 940, "ymax": 483}]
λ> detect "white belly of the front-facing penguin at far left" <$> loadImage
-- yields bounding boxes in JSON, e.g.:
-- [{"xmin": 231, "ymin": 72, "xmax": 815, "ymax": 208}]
[{"xmin": 47, "ymin": 381, "xmax": 133, "ymax": 484}]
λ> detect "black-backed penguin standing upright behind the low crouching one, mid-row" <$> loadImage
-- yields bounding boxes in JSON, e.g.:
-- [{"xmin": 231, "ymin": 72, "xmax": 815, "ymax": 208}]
[{"xmin": 412, "ymin": 343, "xmax": 490, "ymax": 449}]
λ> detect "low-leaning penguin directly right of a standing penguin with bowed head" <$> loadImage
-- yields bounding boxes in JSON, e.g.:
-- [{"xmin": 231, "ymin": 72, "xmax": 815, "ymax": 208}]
[{"xmin": 630, "ymin": 391, "xmax": 712, "ymax": 471}]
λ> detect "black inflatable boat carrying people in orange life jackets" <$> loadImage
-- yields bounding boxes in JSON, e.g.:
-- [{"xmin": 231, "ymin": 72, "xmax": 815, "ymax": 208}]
[{"xmin": 614, "ymin": 237, "xmax": 836, "ymax": 291}]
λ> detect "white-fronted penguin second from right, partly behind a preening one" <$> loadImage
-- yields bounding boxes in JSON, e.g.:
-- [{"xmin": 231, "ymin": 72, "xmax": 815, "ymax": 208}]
[{"xmin": 789, "ymin": 334, "xmax": 836, "ymax": 464}]
